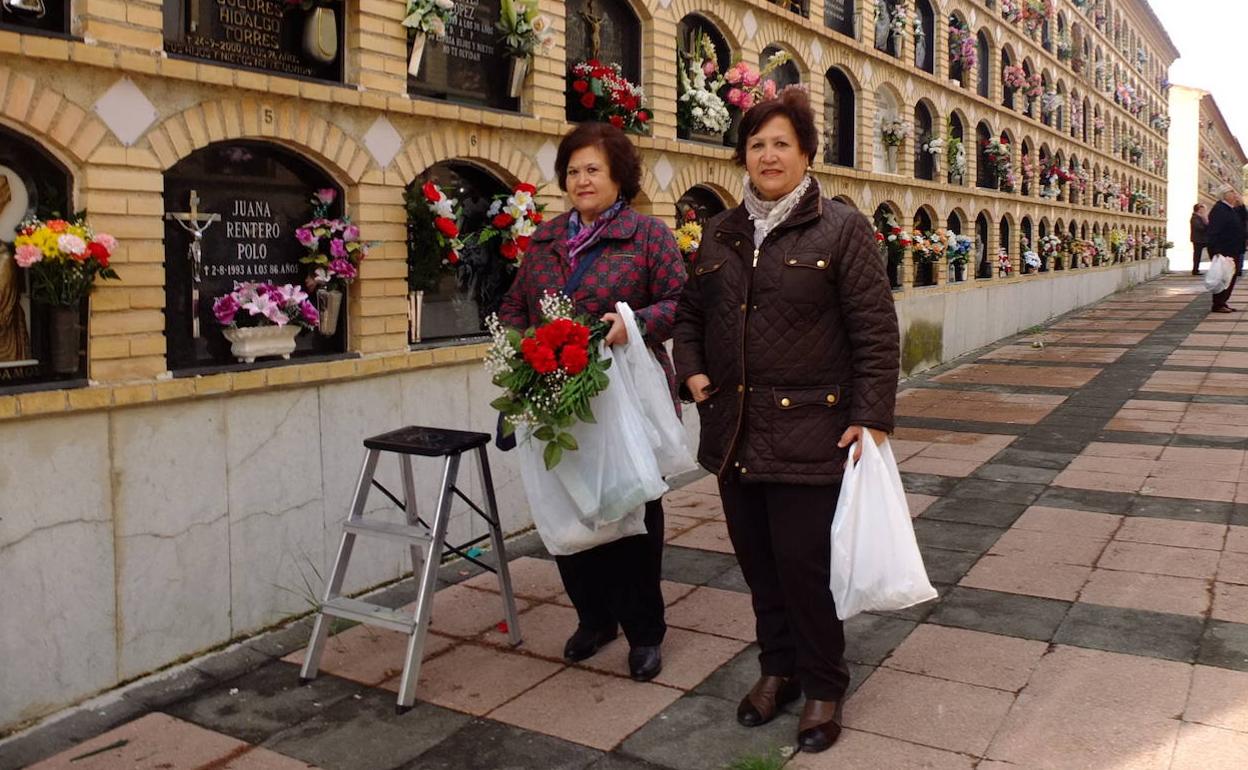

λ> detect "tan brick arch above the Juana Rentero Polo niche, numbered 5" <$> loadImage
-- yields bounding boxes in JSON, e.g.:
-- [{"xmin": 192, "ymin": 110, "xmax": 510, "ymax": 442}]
[{"xmin": 145, "ymin": 99, "xmax": 364, "ymax": 183}]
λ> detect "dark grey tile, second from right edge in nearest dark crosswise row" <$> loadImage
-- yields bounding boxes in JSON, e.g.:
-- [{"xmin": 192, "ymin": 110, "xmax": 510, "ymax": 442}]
[{"xmin": 1053, "ymin": 602, "xmax": 1204, "ymax": 663}]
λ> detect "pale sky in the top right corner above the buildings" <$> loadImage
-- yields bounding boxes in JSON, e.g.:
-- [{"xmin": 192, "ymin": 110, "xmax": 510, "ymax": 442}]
[{"xmin": 1149, "ymin": 0, "xmax": 1248, "ymax": 150}]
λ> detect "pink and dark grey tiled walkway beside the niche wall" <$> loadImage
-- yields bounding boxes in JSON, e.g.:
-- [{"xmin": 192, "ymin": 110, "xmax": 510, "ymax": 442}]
[{"xmin": 0, "ymin": 273, "xmax": 1248, "ymax": 770}]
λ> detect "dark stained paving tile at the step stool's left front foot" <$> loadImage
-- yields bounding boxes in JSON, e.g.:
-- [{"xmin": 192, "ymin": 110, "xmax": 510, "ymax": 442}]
[{"xmin": 166, "ymin": 660, "xmax": 368, "ymax": 744}]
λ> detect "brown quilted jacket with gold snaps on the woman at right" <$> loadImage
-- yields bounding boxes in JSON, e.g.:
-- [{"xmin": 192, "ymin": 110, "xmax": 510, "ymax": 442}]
[{"xmin": 673, "ymin": 185, "xmax": 900, "ymax": 484}]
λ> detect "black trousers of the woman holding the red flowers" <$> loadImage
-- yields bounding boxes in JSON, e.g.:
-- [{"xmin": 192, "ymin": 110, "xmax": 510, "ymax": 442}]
[{"xmin": 554, "ymin": 500, "xmax": 668, "ymax": 646}]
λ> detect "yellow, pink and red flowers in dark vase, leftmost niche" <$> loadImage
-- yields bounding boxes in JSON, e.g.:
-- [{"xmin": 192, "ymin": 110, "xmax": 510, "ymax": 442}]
[{"xmin": 12, "ymin": 212, "xmax": 119, "ymax": 307}]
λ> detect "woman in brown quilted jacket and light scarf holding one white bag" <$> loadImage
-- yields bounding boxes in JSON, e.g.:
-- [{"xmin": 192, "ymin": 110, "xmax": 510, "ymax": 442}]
[{"xmin": 674, "ymin": 89, "xmax": 900, "ymax": 751}]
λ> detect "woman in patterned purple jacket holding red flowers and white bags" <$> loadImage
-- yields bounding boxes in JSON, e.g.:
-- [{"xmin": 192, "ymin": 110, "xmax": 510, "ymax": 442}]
[{"xmin": 499, "ymin": 122, "xmax": 685, "ymax": 681}]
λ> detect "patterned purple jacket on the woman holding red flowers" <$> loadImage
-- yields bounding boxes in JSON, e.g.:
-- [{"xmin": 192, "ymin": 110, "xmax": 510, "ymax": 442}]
[{"xmin": 498, "ymin": 207, "xmax": 685, "ymax": 413}]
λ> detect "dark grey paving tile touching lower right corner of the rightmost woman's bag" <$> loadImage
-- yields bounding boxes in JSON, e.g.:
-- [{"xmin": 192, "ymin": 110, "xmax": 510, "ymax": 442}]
[{"xmin": 927, "ymin": 587, "xmax": 1070, "ymax": 641}]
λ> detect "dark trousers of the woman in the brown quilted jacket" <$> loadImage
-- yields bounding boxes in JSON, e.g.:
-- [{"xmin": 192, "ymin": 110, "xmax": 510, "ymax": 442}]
[{"xmin": 719, "ymin": 479, "xmax": 850, "ymax": 700}]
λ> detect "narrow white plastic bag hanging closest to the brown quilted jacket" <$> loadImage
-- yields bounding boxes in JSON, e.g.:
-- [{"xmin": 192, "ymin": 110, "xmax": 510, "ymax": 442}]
[{"xmin": 613, "ymin": 302, "xmax": 698, "ymax": 478}]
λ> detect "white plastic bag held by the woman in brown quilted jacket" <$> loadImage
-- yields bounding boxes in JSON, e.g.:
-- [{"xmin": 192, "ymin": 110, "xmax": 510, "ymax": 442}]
[{"xmin": 830, "ymin": 436, "xmax": 936, "ymax": 620}]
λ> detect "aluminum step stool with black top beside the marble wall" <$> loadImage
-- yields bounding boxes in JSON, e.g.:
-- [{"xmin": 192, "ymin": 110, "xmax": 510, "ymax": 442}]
[{"xmin": 300, "ymin": 426, "xmax": 520, "ymax": 713}]
